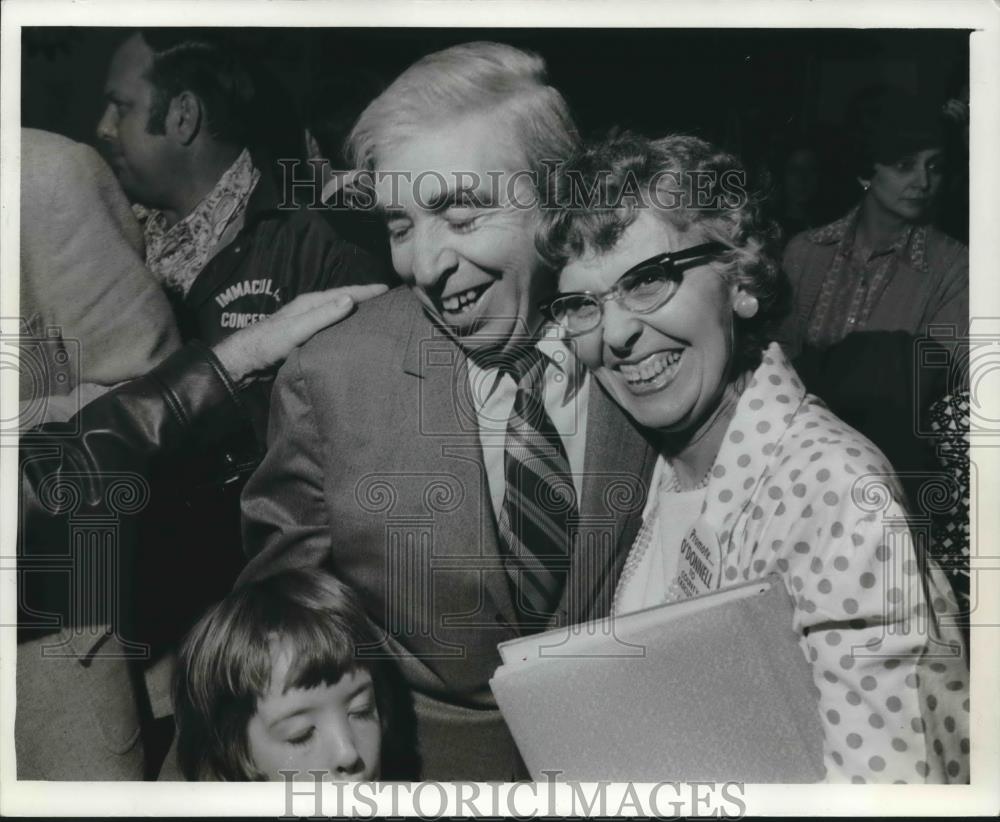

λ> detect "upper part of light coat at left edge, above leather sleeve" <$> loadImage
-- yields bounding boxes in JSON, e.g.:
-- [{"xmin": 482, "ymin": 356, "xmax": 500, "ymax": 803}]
[{"xmin": 20, "ymin": 129, "xmax": 180, "ymax": 402}]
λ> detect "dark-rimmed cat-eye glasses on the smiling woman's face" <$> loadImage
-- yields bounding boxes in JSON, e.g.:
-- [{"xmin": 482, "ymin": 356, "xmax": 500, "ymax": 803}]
[{"xmin": 539, "ymin": 242, "xmax": 729, "ymax": 334}]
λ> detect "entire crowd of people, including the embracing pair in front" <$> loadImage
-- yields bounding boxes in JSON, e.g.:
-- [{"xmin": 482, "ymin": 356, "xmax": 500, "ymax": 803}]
[{"xmin": 15, "ymin": 29, "xmax": 970, "ymax": 783}]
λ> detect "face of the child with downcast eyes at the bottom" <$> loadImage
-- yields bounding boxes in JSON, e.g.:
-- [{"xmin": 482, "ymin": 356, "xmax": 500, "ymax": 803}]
[{"xmin": 247, "ymin": 650, "xmax": 382, "ymax": 781}]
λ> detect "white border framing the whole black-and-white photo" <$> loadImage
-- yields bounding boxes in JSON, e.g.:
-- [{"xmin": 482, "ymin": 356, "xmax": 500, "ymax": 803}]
[{"xmin": 0, "ymin": 0, "xmax": 1000, "ymax": 818}]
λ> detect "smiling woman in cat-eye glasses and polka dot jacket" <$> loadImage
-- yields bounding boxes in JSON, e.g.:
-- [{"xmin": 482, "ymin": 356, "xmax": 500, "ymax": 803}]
[{"xmin": 538, "ymin": 134, "xmax": 969, "ymax": 783}]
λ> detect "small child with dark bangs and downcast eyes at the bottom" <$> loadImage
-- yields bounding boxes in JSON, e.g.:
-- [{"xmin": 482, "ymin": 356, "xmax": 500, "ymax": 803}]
[{"xmin": 174, "ymin": 570, "xmax": 388, "ymax": 781}]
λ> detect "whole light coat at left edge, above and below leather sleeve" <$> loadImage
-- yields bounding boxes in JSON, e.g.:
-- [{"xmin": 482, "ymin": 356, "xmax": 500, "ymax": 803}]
[{"xmin": 15, "ymin": 129, "xmax": 180, "ymax": 780}]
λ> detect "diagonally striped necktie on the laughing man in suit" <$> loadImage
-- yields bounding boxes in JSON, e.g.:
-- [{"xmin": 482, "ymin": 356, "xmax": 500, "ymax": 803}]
[{"xmin": 499, "ymin": 347, "xmax": 577, "ymax": 633}]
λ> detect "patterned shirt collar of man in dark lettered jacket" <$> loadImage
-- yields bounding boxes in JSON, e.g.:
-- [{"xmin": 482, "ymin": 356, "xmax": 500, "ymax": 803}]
[{"xmin": 134, "ymin": 149, "xmax": 260, "ymax": 296}]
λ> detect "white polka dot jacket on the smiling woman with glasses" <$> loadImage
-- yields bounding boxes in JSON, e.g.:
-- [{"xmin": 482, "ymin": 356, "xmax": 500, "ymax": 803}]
[{"xmin": 628, "ymin": 344, "xmax": 969, "ymax": 783}]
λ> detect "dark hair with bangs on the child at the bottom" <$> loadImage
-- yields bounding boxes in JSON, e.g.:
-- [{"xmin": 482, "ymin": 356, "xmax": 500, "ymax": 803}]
[{"xmin": 174, "ymin": 569, "xmax": 388, "ymax": 781}]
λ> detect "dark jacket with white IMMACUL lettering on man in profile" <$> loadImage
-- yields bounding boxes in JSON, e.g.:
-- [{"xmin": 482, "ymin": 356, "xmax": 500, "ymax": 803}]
[{"xmin": 133, "ymin": 157, "xmax": 395, "ymax": 648}]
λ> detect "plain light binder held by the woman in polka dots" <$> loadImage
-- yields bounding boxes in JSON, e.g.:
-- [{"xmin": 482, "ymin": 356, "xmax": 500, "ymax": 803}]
[{"xmin": 490, "ymin": 575, "xmax": 825, "ymax": 782}]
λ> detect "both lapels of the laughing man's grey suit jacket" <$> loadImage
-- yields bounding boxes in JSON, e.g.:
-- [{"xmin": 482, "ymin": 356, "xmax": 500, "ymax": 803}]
[{"xmin": 400, "ymin": 300, "xmax": 656, "ymax": 625}]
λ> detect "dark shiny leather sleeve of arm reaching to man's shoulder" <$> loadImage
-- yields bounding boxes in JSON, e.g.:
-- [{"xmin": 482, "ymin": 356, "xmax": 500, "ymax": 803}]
[{"xmin": 18, "ymin": 342, "xmax": 242, "ymax": 629}]
